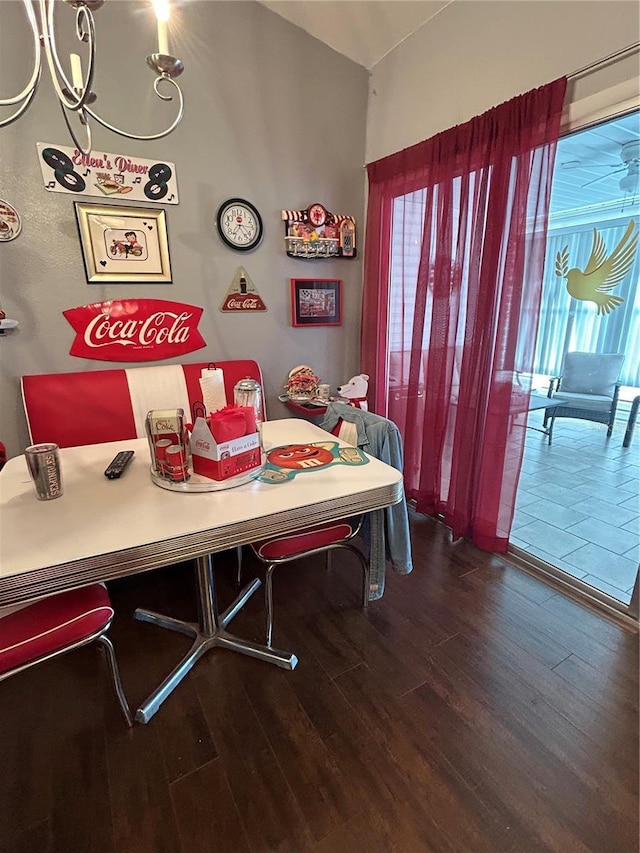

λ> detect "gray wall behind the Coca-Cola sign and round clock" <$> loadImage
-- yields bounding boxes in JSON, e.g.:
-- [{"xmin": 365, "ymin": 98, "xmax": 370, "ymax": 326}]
[{"xmin": 0, "ymin": 0, "xmax": 368, "ymax": 456}]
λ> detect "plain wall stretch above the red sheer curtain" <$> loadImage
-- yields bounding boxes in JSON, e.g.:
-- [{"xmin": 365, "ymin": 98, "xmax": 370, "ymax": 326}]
[{"xmin": 366, "ymin": 0, "xmax": 640, "ymax": 163}]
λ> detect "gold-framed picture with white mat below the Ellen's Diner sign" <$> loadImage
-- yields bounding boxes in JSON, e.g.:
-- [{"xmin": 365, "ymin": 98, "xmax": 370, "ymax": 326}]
[{"xmin": 75, "ymin": 201, "xmax": 171, "ymax": 284}]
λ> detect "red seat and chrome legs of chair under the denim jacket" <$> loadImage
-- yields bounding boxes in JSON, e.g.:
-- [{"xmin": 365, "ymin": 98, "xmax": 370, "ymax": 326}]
[{"xmin": 251, "ymin": 516, "xmax": 369, "ymax": 648}]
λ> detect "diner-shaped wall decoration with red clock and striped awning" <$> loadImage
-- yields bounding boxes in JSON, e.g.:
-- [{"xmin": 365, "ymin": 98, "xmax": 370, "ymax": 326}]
[{"xmin": 282, "ymin": 202, "xmax": 357, "ymax": 260}]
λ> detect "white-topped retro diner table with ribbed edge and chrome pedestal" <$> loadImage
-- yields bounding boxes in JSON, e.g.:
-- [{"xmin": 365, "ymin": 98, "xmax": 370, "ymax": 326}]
[{"xmin": 0, "ymin": 419, "xmax": 403, "ymax": 723}]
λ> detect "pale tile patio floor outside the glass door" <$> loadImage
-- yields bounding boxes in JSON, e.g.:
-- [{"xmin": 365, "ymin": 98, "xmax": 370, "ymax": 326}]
[{"xmin": 510, "ymin": 403, "xmax": 640, "ymax": 604}]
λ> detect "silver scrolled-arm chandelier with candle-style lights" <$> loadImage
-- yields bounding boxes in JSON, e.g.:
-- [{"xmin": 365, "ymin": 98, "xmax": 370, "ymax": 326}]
[{"xmin": 0, "ymin": 0, "xmax": 184, "ymax": 154}]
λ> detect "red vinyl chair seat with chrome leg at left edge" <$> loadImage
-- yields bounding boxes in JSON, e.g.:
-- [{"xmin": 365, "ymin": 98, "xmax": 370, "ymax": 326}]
[{"xmin": 0, "ymin": 583, "xmax": 133, "ymax": 726}]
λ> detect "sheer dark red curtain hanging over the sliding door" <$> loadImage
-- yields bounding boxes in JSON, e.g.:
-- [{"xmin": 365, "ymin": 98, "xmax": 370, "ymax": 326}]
[{"xmin": 361, "ymin": 78, "xmax": 566, "ymax": 553}]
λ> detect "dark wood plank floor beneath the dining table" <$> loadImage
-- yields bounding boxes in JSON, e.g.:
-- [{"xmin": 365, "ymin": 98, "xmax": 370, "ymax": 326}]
[{"xmin": 0, "ymin": 516, "xmax": 638, "ymax": 853}]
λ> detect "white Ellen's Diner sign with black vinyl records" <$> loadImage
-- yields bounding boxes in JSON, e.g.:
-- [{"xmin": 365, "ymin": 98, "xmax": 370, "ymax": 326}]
[{"xmin": 36, "ymin": 142, "xmax": 179, "ymax": 204}]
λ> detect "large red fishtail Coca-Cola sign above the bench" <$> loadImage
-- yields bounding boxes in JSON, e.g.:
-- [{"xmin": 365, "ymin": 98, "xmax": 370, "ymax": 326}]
[{"xmin": 62, "ymin": 299, "xmax": 206, "ymax": 361}]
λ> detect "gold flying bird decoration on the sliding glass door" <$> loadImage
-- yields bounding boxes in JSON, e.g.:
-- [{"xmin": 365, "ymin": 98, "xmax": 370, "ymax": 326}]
[{"xmin": 556, "ymin": 219, "xmax": 638, "ymax": 314}]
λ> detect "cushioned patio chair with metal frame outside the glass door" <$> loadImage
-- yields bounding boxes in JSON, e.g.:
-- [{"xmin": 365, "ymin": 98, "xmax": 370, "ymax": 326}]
[{"xmin": 543, "ymin": 352, "xmax": 624, "ymax": 444}]
